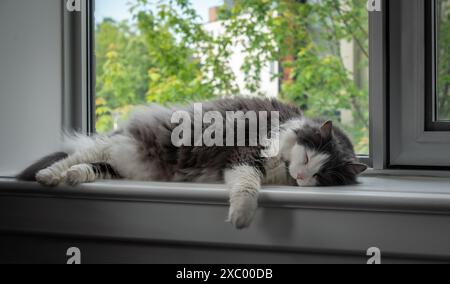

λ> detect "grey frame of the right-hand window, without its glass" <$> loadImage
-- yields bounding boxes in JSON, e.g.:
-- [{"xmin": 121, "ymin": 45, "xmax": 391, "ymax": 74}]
[{"xmin": 387, "ymin": 0, "xmax": 450, "ymax": 170}]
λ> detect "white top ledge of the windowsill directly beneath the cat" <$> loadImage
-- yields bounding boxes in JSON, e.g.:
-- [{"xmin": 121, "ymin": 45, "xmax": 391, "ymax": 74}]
[{"xmin": 0, "ymin": 175, "xmax": 450, "ymax": 213}]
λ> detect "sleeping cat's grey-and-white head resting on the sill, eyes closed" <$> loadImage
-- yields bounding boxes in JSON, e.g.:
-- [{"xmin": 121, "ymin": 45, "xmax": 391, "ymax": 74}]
[{"xmin": 283, "ymin": 120, "xmax": 367, "ymax": 187}]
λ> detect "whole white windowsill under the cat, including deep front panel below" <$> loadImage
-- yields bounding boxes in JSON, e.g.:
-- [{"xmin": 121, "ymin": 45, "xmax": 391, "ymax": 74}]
[{"xmin": 0, "ymin": 177, "xmax": 450, "ymax": 260}]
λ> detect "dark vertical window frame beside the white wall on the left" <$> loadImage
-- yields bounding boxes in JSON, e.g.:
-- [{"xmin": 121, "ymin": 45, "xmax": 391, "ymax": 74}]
[{"xmin": 62, "ymin": 0, "xmax": 95, "ymax": 135}]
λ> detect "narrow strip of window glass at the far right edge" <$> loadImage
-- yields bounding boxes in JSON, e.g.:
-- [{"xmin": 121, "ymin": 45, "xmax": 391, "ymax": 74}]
[{"xmin": 436, "ymin": 0, "xmax": 450, "ymax": 121}]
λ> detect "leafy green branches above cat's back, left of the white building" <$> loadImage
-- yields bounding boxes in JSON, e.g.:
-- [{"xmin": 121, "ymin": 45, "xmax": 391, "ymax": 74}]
[{"xmin": 137, "ymin": 3, "xmax": 214, "ymax": 104}]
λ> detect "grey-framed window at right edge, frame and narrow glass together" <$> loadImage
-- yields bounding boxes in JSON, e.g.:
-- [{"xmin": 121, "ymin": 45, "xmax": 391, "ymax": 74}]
[{"xmin": 388, "ymin": 0, "xmax": 450, "ymax": 169}]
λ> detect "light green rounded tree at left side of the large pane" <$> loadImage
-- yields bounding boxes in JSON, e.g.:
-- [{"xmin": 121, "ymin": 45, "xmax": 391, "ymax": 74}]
[{"xmin": 96, "ymin": 19, "xmax": 152, "ymax": 132}]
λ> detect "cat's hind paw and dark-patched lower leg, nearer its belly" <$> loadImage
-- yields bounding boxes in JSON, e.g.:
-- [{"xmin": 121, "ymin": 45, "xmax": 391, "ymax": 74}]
[{"xmin": 64, "ymin": 163, "xmax": 120, "ymax": 186}]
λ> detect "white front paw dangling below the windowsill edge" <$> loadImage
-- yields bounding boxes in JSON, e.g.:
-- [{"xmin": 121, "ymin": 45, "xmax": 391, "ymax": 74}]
[{"xmin": 228, "ymin": 197, "xmax": 258, "ymax": 230}]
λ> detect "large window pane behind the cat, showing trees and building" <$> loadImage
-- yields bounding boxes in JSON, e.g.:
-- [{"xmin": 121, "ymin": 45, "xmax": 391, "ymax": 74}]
[{"xmin": 91, "ymin": 0, "xmax": 369, "ymax": 155}]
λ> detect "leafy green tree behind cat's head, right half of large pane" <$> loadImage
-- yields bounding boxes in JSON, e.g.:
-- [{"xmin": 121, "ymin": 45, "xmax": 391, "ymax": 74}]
[{"xmin": 217, "ymin": 0, "xmax": 369, "ymax": 153}]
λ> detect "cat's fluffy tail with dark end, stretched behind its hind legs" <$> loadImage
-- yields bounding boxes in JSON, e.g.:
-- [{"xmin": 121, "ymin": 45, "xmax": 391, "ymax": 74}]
[{"xmin": 16, "ymin": 133, "xmax": 95, "ymax": 182}]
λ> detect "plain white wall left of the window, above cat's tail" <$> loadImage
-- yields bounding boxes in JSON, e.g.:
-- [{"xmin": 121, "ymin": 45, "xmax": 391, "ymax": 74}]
[{"xmin": 0, "ymin": 0, "xmax": 62, "ymax": 175}]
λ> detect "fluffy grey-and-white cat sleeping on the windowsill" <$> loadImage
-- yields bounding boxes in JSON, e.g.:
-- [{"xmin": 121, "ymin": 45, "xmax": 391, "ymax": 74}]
[{"xmin": 17, "ymin": 97, "xmax": 367, "ymax": 229}]
